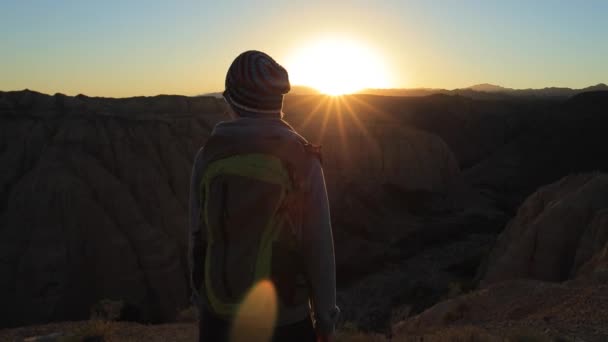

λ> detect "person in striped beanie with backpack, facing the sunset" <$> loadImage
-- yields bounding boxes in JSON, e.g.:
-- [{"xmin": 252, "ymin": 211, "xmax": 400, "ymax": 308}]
[{"xmin": 189, "ymin": 51, "xmax": 339, "ymax": 341}]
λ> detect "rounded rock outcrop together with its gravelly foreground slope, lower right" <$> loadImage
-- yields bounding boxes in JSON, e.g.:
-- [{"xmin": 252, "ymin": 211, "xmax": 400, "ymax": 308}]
[{"xmin": 394, "ymin": 173, "xmax": 608, "ymax": 341}]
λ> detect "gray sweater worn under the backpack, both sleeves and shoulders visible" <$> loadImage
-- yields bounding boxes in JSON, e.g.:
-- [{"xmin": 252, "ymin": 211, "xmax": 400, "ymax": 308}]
[{"xmin": 189, "ymin": 118, "xmax": 339, "ymax": 333}]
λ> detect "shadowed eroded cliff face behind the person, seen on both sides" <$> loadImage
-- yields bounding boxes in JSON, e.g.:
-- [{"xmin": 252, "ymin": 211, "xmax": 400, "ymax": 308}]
[{"xmin": 0, "ymin": 91, "xmax": 459, "ymax": 325}]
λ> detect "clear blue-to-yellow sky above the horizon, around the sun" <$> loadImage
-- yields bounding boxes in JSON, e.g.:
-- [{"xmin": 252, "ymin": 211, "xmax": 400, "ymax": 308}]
[{"xmin": 0, "ymin": 0, "xmax": 608, "ymax": 97}]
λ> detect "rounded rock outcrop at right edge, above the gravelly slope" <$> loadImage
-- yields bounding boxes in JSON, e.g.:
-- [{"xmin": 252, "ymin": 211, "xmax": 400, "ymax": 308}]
[{"xmin": 481, "ymin": 173, "xmax": 608, "ymax": 286}]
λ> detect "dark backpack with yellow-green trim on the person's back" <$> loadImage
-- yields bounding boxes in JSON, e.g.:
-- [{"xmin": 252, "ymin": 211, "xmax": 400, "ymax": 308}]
[{"xmin": 200, "ymin": 124, "xmax": 319, "ymax": 319}]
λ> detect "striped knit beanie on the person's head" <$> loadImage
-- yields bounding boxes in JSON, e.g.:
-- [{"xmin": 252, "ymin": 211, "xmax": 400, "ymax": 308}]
[{"xmin": 224, "ymin": 50, "xmax": 291, "ymax": 117}]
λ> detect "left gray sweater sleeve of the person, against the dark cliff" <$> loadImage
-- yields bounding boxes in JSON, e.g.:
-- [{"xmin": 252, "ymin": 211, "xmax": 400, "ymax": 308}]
[{"xmin": 188, "ymin": 149, "xmax": 206, "ymax": 304}]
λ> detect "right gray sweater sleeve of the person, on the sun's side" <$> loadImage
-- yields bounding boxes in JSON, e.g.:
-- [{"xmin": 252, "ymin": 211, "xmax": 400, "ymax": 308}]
[{"xmin": 302, "ymin": 159, "xmax": 340, "ymax": 334}]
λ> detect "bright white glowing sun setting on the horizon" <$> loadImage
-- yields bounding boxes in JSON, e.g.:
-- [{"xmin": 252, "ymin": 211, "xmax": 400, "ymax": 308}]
[{"xmin": 286, "ymin": 38, "xmax": 390, "ymax": 96}]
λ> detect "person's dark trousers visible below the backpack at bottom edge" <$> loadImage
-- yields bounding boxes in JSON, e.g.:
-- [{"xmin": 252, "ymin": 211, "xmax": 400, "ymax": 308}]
[{"xmin": 198, "ymin": 310, "xmax": 316, "ymax": 342}]
